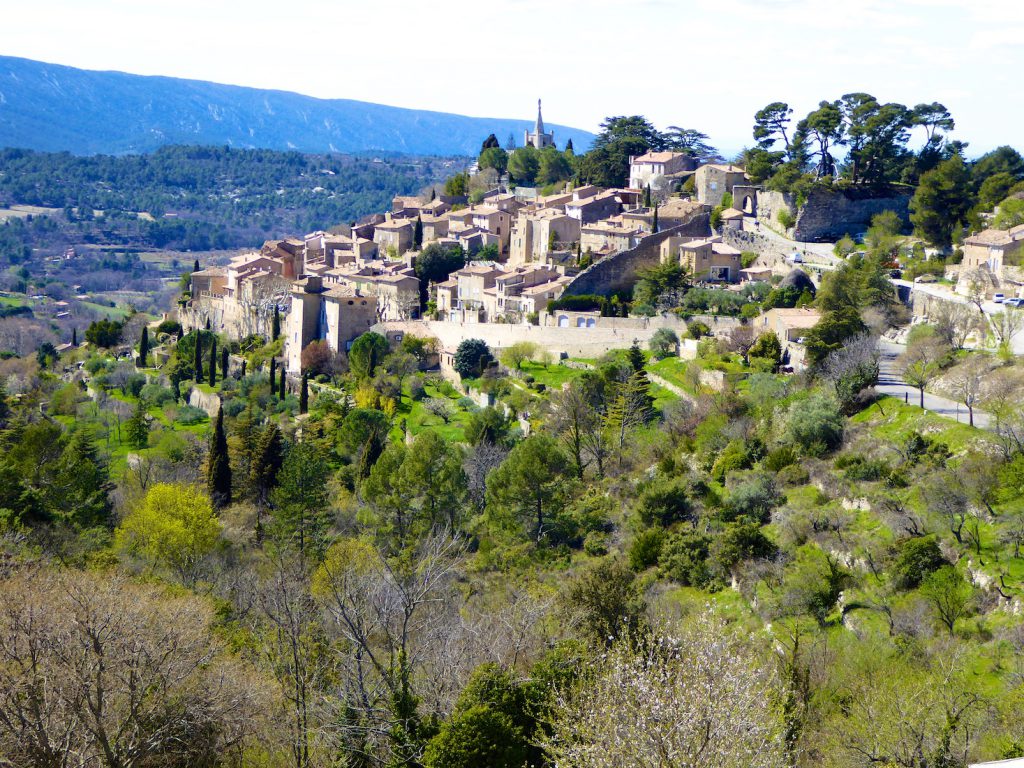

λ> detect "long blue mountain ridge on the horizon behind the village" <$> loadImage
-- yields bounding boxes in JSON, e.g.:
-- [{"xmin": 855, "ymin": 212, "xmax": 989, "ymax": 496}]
[{"xmin": 0, "ymin": 56, "xmax": 594, "ymax": 156}]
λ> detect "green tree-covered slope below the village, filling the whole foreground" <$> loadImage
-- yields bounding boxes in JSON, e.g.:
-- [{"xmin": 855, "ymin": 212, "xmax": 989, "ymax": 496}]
[{"xmin": 0, "ymin": 243, "xmax": 1024, "ymax": 768}]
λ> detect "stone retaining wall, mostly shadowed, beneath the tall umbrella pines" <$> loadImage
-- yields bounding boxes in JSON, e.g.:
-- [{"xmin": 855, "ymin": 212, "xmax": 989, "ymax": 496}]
[{"xmin": 758, "ymin": 189, "xmax": 910, "ymax": 242}]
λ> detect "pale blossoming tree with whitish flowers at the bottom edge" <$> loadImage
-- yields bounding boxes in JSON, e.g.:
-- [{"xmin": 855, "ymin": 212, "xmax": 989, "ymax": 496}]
[{"xmin": 545, "ymin": 616, "xmax": 788, "ymax": 768}]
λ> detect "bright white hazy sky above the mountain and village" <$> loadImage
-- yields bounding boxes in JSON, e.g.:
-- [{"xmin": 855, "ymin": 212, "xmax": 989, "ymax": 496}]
[{"xmin": 0, "ymin": 0, "xmax": 1024, "ymax": 154}]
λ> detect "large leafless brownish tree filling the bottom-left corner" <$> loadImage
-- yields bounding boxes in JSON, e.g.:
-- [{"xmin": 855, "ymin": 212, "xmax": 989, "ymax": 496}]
[{"xmin": 0, "ymin": 570, "xmax": 269, "ymax": 768}]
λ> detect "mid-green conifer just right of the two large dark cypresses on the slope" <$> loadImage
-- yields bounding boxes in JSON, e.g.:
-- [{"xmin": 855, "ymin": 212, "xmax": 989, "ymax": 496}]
[{"xmin": 270, "ymin": 441, "xmax": 331, "ymax": 557}]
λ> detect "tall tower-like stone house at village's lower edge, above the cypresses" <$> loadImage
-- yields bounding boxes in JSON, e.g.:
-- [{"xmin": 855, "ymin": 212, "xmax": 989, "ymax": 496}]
[{"xmin": 285, "ymin": 276, "xmax": 377, "ymax": 376}]
